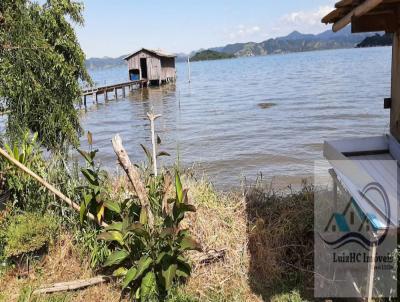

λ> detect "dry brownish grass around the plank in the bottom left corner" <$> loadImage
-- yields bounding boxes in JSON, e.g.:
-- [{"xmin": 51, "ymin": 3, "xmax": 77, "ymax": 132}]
[{"xmin": 0, "ymin": 233, "xmax": 120, "ymax": 302}]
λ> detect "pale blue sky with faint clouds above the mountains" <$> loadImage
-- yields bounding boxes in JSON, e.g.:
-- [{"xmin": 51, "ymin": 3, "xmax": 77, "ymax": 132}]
[{"xmin": 77, "ymin": 0, "xmax": 335, "ymax": 58}]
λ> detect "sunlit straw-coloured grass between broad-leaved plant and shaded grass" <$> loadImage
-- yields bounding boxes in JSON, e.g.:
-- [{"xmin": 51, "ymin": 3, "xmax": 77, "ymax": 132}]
[{"xmin": 183, "ymin": 179, "xmax": 262, "ymax": 301}]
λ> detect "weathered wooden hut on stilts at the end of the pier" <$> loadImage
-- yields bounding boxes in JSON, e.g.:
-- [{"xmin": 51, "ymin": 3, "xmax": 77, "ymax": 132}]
[{"xmin": 125, "ymin": 48, "xmax": 176, "ymax": 85}]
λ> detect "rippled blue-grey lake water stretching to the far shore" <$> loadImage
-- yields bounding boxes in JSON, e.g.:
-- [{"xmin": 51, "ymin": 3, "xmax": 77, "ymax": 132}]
[{"xmin": 82, "ymin": 47, "xmax": 391, "ymax": 188}]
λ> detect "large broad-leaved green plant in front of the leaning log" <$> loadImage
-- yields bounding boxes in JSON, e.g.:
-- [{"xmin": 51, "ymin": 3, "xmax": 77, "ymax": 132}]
[{"xmin": 98, "ymin": 173, "xmax": 201, "ymax": 301}]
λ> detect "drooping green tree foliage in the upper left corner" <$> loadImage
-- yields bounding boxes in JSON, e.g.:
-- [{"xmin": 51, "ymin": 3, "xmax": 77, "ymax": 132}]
[{"xmin": 0, "ymin": 0, "xmax": 90, "ymax": 150}]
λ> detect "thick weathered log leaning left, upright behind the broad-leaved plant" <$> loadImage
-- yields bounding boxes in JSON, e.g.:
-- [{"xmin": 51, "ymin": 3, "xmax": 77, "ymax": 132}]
[{"xmin": 112, "ymin": 134, "xmax": 154, "ymax": 228}]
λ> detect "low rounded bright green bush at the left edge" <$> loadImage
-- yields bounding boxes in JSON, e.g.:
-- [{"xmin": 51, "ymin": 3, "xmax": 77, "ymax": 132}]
[{"xmin": 4, "ymin": 212, "xmax": 58, "ymax": 258}]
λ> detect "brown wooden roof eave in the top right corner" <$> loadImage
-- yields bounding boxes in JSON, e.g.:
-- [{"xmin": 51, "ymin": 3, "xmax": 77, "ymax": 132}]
[{"xmin": 322, "ymin": 0, "xmax": 400, "ymax": 33}]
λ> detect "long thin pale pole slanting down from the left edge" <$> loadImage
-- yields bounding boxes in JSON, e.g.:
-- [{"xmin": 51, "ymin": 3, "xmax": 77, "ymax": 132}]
[{"xmin": 0, "ymin": 148, "xmax": 107, "ymax": 226}]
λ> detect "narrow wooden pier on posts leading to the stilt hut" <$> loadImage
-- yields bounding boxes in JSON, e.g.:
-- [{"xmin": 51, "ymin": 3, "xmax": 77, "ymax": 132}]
[{"xmin": 82, "ymin": 80, "xmax": 147, "ymax": 107}]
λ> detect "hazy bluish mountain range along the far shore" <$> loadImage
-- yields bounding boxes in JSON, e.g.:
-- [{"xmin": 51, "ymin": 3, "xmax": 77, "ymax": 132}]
[{"xmin": 86, "ymin": 26, "xmax": 380, "ymax": 69}]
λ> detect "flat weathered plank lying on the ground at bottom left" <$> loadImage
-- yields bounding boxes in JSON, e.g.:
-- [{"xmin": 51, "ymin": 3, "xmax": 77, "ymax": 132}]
[{"xmin": 32, "ymin": 276, "xmax": 110, "ymax": 295}]
